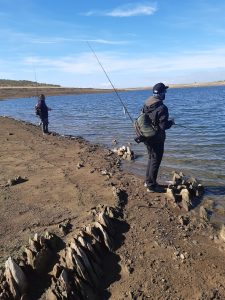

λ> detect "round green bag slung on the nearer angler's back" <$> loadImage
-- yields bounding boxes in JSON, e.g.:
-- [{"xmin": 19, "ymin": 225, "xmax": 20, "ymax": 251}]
[{"xmin": 134, "ymin": 113, "xmax": 158, "ymax": 139}]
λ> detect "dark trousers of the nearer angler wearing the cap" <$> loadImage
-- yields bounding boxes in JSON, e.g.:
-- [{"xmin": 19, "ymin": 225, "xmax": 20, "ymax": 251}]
[{"xmin": 146, "ymin": 141, "xmax": 164, "ymax": 187}]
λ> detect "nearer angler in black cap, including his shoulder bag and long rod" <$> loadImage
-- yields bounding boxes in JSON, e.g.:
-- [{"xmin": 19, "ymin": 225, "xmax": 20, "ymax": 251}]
[{"xmin": 87, "ymin": 42, "xmax": 175, "ymax": 192}]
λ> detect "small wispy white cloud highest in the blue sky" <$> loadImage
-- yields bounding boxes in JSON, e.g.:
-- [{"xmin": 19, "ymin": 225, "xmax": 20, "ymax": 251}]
[{"xmin": 85, "ymin": 3, "xmax": 157, "ymax": 18}]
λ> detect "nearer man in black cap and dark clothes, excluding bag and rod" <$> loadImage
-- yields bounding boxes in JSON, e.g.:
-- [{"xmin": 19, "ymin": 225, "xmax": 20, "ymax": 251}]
[{"xmin": 143, "ymin": 82, "xmax": 175, "ymax": 192}]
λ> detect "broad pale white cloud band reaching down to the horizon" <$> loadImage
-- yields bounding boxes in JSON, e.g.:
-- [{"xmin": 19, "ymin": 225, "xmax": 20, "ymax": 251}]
[{"xmin": 1, "ymin": 48, "xmax": 225, "ymax": 88}]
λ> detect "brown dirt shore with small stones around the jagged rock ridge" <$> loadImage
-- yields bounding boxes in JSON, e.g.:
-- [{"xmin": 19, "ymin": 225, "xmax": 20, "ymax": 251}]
[{"xmin": 0, "ymin": 117, "xmax": 225, "ymax": 300}]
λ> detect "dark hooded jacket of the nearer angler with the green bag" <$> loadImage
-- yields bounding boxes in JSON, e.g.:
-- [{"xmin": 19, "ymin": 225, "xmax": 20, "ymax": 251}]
[{"xmin": 142, "ymin": 96, "xmax": 173, "ymax": 143}]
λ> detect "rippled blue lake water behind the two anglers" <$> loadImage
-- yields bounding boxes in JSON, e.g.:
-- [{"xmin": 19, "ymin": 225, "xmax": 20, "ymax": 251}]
[{"xmin": 0, "ymin": 87, "xmax": 225, "ymax": 220}]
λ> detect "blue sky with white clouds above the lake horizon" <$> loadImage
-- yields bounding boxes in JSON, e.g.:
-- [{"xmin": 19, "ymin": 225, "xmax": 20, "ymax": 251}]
[{"xmin": 0, "ymin": 0, "xmax": 225, "ymax": 88}]
